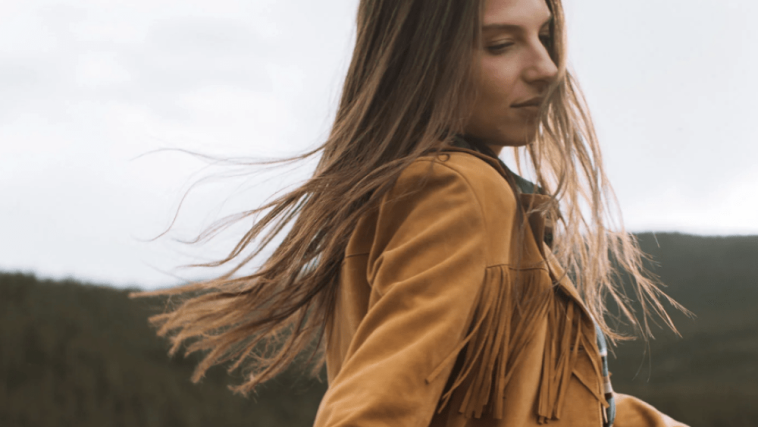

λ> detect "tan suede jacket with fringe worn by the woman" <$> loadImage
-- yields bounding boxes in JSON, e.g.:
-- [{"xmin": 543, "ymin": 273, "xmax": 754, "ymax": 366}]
[{"xmin": 315, "ymin": 148, "xmax": 683, "ymax": 427}]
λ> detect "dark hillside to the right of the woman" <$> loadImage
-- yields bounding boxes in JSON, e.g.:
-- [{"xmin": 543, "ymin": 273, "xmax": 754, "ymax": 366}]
[{"xmin": 609, "ymin": 233, "xmax": 758, "ymax": 427}]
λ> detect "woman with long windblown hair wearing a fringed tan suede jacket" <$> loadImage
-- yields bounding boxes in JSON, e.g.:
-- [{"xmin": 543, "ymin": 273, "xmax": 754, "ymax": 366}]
[{"xmin": 134, "ymin": 0, "xmax": 692, "ymax": 427}]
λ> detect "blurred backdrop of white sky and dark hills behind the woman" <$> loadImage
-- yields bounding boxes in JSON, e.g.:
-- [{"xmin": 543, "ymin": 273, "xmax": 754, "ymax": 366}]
[{"xmin": 0, "ymin": 0, "xmax": 758, "ymax": 426}]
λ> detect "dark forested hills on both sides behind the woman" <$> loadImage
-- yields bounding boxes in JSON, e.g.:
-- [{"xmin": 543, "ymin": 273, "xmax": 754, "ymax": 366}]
[{"xmin": 0, "ymin": 234, "xmax": 758, "ymax": 427}]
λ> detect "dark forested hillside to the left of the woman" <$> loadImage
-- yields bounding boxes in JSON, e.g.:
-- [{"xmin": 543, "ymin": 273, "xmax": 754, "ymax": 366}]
[{"xmin": 0, "ymin": 274, "xmax": 326, "ymax": 427}]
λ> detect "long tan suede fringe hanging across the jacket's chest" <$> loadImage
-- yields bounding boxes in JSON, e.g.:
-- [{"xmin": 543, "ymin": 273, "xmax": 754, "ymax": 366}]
[{"xmin": 426, "ymin": 266, "xmax": 605, "ymax": 424}]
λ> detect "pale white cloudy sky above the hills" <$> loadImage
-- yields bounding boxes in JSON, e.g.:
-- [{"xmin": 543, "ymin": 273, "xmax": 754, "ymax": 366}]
[{"xmin": 0, "ymin": 0, "xmax": 758, "ymax": 287}]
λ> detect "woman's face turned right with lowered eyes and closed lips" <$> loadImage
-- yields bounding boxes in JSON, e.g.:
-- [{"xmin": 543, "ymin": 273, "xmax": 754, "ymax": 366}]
[{"xmin": 465, "ymin": 0, "xmax": 558, "ymax": 153}]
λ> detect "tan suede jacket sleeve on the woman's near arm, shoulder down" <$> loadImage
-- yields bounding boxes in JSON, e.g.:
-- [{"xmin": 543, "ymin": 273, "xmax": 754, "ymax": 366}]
[{"xmin": 315, "ymin": 161, "xmax": 486, "ymax": 427}]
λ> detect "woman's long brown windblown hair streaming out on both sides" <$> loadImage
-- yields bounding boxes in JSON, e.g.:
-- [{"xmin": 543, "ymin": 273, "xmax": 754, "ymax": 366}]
[{"xmin": 135, "ymin": 0, "xmax": 688, "ymax": 393}]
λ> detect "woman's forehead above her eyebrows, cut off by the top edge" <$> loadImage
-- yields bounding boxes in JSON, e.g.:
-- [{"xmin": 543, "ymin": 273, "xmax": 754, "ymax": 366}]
[{"xmin": 482, "ymin": 0, "xmax": 551, "ymax": 27}]
